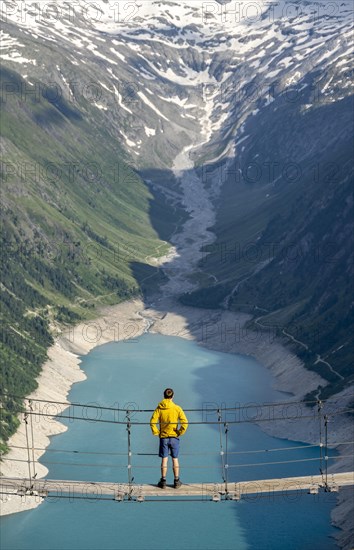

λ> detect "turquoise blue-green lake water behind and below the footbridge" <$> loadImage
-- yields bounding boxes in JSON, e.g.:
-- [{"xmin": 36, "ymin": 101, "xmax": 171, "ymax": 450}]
[{"xmin": 0, "ymin": 334, "xmax": 337, "ymax": 550}]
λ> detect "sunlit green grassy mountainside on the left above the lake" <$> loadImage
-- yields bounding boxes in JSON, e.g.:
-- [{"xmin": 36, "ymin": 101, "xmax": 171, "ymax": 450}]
[{"xmin": 0, "ymin": 68, "xmax": 168, "ymax": 451}]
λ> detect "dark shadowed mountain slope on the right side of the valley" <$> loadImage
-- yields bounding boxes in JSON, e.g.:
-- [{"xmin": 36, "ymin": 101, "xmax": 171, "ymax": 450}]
[{"xmin": 210, "ymin": 90, "xmax": 354, "ymax": 397}]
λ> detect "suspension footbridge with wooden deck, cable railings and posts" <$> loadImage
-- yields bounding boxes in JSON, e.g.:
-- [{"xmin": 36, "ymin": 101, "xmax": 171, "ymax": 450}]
[{"xmin": 0, "ymin": 399, "xmax": 354, "ymax": 502}]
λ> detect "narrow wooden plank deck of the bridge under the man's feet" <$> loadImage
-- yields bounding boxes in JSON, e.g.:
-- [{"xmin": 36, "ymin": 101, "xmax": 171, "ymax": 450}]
[{"xmin": 0, "ymin": 472, "xmax": 354, "ymax": 501}]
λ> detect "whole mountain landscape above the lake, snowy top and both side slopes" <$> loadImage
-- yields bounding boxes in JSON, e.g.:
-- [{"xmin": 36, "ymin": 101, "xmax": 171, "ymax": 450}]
[{"xmin": 1, "ymin": 0, "xmax": 353, "ymax": 440}]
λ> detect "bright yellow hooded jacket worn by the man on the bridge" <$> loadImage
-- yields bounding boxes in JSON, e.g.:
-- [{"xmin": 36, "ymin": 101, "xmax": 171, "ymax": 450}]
[{"xmin": 150, "ymin": 399, "xmax": 188, "ymax": 437}]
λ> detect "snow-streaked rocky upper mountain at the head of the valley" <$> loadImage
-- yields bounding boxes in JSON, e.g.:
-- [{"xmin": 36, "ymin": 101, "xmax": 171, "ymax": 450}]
[{"xmin": 2, "ymin": 0, "xmax": 353, "ymax": 169}]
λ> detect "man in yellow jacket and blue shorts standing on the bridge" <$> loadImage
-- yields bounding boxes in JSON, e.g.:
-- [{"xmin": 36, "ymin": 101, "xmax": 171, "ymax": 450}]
[{"xmin": 150, "ymin": 388, "xmax": 188, "ymax": 489}]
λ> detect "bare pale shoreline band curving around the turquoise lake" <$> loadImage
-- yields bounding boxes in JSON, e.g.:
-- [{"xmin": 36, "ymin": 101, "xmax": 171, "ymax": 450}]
[{"xmin": 1, "ymin": 300, "xmax": 352, "ymax": 548}]
